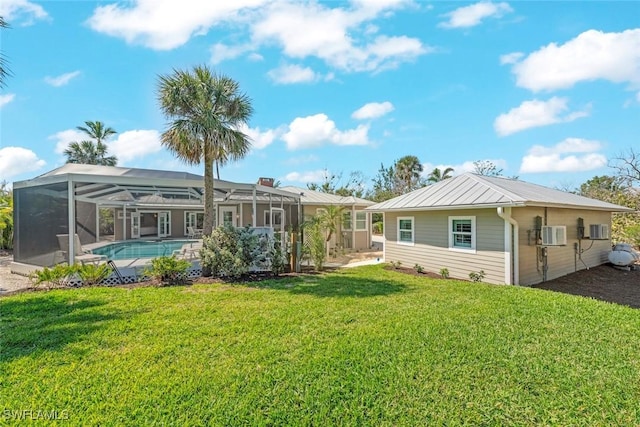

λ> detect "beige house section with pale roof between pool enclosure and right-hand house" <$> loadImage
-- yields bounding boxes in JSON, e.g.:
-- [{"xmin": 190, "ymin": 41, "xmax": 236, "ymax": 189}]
[{"xmin": 282, "ymin": 187, "xmax": 374, "ymax": 250}]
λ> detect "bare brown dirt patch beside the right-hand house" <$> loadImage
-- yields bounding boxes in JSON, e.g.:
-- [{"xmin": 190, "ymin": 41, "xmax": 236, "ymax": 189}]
[{"xmin": 532, "ymin": 264, "xmax": 640, "ymax": 308}]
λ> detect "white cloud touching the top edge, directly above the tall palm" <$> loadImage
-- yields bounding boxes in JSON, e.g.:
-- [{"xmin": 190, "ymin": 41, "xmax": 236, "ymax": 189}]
[{"xmin": 87, "ymin": 0, "xmax": 266, "ymax": 50}]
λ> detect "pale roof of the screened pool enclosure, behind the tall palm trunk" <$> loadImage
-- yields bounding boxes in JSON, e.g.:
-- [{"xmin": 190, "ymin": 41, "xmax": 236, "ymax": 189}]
[{"xmin": 13, "ymin": 163, "xmax": 300, "ymax": 206}]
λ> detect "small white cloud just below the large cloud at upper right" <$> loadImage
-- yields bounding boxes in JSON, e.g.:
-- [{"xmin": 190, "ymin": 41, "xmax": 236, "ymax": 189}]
[{"xmin": 493, "ymin": 96, "xmax": 589, "ymax": 136}]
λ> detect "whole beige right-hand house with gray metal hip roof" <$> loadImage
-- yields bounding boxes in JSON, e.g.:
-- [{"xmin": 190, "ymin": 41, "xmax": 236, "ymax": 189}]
[{"xmin": 367, "ymin": 173, "xmax": 631, "ymax": 285}]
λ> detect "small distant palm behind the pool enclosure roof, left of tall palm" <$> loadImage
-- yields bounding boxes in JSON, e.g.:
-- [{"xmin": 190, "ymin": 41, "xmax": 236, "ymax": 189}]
[{"xmin": 64, "ymin": 121, "xmax": 118, "ymax": 166}]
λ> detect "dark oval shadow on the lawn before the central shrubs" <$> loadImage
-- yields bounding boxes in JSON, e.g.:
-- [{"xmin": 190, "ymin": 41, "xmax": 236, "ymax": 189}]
[{"xmin": 243, "ymin": 273, "xmax": 409, "ymax": 298}]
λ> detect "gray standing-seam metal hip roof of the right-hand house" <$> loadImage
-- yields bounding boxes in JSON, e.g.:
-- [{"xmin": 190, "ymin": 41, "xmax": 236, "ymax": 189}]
[{"xmin": 367, "ymin": 173, "xmax": 632, "ymax": 212}]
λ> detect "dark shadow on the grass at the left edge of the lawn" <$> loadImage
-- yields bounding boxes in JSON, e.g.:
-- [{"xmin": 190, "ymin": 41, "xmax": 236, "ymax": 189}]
[{"xmin": 0, "ymin": 295, "xmax": 121, "ymax": 362}]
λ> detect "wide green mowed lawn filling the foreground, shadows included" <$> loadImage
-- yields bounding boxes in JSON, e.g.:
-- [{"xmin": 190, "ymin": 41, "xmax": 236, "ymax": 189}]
[{"xmin": 0, "ymin": 266, "xmax": 640, "ymax": 426}]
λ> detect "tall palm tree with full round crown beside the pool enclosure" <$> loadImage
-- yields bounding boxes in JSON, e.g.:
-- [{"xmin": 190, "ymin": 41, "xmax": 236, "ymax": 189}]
[{"xmin": 158, "ymin": 65, "xmax": 253, "ymax": 235}]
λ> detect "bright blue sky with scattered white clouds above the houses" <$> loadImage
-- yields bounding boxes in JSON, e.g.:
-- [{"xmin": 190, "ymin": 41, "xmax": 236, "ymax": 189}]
[{"xmin": 0, "ymin": 0, "xmax": 640, "ymax": 188}]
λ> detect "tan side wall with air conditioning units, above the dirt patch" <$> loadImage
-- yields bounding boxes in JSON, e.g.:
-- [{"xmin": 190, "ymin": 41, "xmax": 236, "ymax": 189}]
[{"xmin": 511, "ymin": 207, "xmax": 611, "ymax": 285}]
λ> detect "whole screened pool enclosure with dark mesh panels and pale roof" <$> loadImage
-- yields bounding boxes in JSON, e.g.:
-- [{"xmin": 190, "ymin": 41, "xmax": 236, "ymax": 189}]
[{"xmin": 13, "ymin": 164, "xmax": 301, "ymax": 266}]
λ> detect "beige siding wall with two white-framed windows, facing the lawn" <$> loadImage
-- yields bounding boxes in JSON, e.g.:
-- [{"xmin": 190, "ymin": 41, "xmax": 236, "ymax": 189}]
[{"xmin": 384, "ymin": 209, "xmax": 505, "ymax": 284}]
